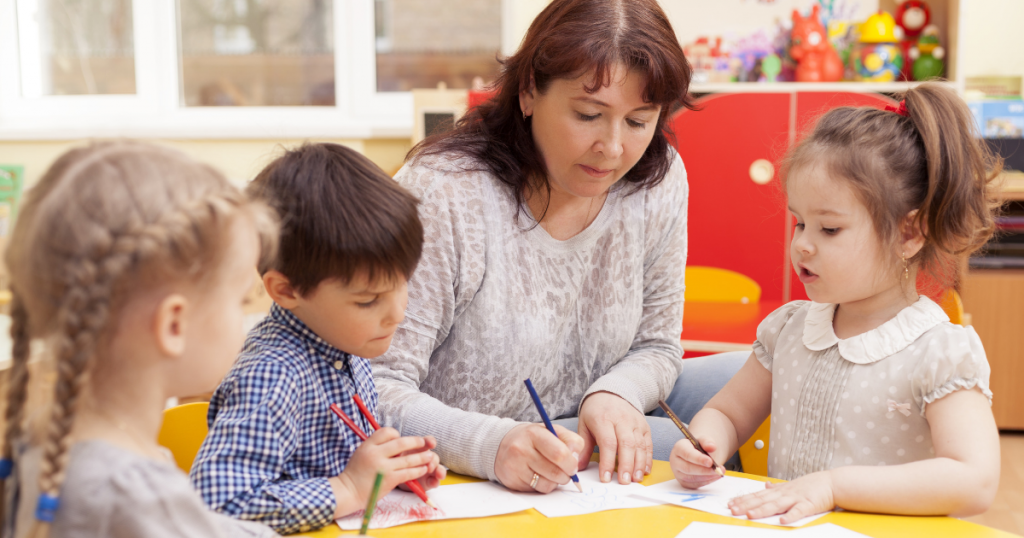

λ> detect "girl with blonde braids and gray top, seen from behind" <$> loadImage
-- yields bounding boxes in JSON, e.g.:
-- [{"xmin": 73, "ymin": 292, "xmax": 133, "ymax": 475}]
[{"xmin": 0, "ymin": 141, "xmax": 276, "ymax": 538}]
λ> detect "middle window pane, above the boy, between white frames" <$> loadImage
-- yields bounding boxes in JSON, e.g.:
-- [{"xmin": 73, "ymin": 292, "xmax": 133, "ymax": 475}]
[{"xmin": 178, "ymin": 0, "xmax": 335, "ymax": 107}]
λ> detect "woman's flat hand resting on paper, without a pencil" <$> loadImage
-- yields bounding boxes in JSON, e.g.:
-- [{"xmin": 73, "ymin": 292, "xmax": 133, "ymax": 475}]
[{"xmin": 578, "ymin": 392, "xmax": 654, "ymax": 484}]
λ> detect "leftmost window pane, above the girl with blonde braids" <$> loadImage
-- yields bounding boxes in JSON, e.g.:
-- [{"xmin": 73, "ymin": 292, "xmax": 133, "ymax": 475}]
[{"xmin": 16, "ymin": 0, "xmax": 135, "ymax": 97}]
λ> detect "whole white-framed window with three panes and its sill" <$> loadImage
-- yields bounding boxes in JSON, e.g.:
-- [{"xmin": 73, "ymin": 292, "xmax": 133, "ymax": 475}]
[{"xmin": 0, "ymin": 0, "xmax": 524, "ymax": 139}]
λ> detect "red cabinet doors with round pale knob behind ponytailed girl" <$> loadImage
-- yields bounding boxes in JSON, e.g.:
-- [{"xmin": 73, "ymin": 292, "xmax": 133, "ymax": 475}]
[{"xmin": 670, "ymin": 91, "xmax": 892, "ymax": 301}]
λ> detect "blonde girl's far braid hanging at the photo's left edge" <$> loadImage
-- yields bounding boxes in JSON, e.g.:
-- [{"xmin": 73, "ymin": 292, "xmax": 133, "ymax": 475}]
[{"xmin": 0, "ymin": 293, "xmax": 30, "ymax": 528}]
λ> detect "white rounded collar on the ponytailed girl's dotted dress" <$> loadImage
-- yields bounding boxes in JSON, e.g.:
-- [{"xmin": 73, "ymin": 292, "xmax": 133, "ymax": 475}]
[{"xmin": 804, "ymin": 295, "xmax": 949, "ymax": 364}]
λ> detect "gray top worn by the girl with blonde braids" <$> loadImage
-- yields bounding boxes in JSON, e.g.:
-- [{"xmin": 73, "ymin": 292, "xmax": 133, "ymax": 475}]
[{"xmin": 3, "ymin": 440, "xmax": 278, "ymax": 538}]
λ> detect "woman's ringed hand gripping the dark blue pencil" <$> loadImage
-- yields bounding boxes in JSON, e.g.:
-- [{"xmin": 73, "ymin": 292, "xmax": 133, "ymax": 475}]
[{"xmin": 495, "ymin": 424, "xmax": 589, "ymax": 493}]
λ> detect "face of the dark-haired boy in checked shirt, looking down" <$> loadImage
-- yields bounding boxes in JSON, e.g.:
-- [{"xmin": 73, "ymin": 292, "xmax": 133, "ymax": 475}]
[{"xmin": 289, "ymin": 272, "xmax": 409, "ymax": 359}]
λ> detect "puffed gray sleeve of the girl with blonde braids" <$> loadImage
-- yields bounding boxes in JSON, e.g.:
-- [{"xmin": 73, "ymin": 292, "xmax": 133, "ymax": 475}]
[{"xmin": 105, "ymin": 463, "xmax": 278, "ymax": 538}]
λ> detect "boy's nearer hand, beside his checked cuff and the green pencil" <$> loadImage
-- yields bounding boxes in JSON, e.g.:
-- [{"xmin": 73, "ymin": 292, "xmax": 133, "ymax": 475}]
[{"xmin": 329, "ymin": 427, "xmax": 437, "ymax": 518}]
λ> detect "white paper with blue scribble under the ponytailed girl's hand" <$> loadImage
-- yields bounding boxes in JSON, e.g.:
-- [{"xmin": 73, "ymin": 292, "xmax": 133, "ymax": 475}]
[{"xmin": 634, "ymin": 477, "xmax": 827, "ymax": 527}]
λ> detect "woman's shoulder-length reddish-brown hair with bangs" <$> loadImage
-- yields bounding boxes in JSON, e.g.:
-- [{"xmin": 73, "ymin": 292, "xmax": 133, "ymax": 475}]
[{"xmin": 409, "ymin": 0, "xmax": 693, "ymax": 220}]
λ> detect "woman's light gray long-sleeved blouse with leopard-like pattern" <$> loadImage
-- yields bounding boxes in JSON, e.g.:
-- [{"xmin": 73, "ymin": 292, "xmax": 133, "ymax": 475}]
[{"xmin": 371, "ymin": 153, "xmax": 687, "ymax": 480}]
